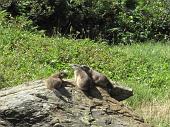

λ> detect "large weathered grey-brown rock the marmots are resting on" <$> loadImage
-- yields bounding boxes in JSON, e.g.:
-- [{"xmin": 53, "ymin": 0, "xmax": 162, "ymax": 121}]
[{"xmin": 0, "ymin": 81, "xmax": 148, "ymax": 127}]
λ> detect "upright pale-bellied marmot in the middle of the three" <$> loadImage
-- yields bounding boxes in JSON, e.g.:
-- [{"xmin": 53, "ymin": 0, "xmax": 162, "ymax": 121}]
[{"xmin": 71, "ymin": 64, "xmax": 93, "ymax": 91}]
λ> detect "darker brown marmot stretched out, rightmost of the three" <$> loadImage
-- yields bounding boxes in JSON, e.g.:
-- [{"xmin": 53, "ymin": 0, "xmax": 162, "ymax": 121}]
[{"xmin": 81, "ymin": 65, "xmax": 113, "ymax": 93}]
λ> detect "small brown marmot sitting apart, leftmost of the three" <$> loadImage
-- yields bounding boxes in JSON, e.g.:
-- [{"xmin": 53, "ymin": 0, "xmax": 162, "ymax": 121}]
[{"xmin": 45, "ymin": 71, "xmax": 67, "ymax": 90}]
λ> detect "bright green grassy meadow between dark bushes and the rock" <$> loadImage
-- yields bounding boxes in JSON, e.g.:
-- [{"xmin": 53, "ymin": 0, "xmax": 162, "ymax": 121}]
[{"xmin": 0, "ymin": 13, "xmax": 170, "ymax": 127}]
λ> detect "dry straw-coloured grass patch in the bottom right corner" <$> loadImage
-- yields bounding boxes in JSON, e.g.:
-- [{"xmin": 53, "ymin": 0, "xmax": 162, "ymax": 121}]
[{"xmin": 137, "ymin": 100, "xmax": 170, "ymax": 127}]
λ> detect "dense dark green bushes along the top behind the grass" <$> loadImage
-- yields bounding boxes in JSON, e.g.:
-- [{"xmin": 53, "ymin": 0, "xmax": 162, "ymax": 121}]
[{"xmin": 2, "ymin": 0, "xmax": 170, "ymax": 44}]
